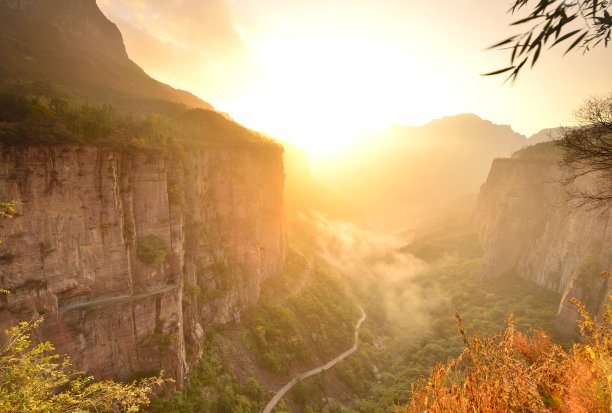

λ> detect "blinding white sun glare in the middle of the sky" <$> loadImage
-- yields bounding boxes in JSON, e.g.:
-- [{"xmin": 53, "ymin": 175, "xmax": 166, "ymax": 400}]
[{"xmin": 222, "ymin": 14, "xmax": 452, "ymax": 156}]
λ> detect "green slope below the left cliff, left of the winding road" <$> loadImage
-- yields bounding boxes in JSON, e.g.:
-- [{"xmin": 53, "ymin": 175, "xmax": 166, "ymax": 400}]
[{"xmin": 151, "ymin": 243, "xmax": 357, "ymax": 413}]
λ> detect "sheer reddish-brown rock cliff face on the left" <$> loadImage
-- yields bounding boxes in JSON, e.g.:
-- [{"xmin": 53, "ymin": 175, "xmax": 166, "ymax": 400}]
[{"xmin": 0, "ymin": 145, "xmax": 284, "ymax": 384}]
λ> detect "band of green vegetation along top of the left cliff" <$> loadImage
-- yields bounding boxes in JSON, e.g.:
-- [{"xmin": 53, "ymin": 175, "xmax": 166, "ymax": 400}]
[{"xmin": 0, "ymin": 93, "xmax": 280, "ymax": 153}]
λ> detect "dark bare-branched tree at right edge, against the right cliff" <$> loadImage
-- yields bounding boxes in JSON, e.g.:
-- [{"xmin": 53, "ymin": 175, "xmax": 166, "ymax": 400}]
[{"xmin": 557, "ymin": 93, "xmax": 612, "ymax": 208}]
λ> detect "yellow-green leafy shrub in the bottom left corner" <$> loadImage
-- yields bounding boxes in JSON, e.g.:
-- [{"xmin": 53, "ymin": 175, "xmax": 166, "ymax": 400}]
[{"xmin": 0, "ymin": 320, "xmax": 163, "ymax": 413}]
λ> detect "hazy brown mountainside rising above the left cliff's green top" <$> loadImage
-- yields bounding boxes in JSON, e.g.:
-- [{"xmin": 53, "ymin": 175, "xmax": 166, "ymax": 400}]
[{"xmin": 0, "ymin": 0, "xmax": 212, "ymax": 112}]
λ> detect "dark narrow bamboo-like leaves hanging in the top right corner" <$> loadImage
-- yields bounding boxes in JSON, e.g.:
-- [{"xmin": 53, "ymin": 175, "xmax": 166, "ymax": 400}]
[{"xmin": 486, "ymin": 0, "xmax": 612, "ymax": 81}]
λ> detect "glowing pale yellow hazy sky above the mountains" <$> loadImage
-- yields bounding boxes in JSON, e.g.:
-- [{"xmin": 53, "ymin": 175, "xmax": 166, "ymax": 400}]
[{"xmin": 98, "ymin": 0, "xmax": 612, "ymax": 151}]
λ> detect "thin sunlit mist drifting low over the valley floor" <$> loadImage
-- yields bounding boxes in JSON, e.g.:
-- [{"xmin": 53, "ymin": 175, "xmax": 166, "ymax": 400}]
[{"xmin": 301, "ymin": 213, "xmax": 445, "ymax": 336}]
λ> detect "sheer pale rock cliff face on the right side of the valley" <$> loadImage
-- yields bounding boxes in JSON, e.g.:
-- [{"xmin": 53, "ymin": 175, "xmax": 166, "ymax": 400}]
[{"xmin": 476, "ymin": 150, "xmax": 612, "ymax": 332}]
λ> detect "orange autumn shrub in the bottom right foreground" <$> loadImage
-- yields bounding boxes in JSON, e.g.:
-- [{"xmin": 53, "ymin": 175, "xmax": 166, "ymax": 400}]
[{"xmin": 398, "ymin": 300, "xmax": 612, "ymax": 413}]
